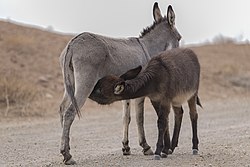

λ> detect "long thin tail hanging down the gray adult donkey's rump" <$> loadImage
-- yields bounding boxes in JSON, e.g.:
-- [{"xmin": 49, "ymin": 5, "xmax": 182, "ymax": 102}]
[{"xmin": 63, "ymin": 43, "xmax": 81, "ymax": 118}]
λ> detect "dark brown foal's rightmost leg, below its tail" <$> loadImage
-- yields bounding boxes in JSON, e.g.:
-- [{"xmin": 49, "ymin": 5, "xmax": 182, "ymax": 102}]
[{"xmin": 188, "ymin": 96, "xmax": 199, "ymax": 155}]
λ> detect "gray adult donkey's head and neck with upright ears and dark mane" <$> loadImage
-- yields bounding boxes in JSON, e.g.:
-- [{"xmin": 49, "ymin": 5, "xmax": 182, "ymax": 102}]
[{"xmin": 140, "ymin": 2, "xmax": 181, "ymax": 57}]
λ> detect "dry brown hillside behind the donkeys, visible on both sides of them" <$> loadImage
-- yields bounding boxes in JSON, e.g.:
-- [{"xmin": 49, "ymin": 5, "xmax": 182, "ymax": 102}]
[{"xmin": 0, "ymin": 21, "xmax": 250, "ymax": 116}]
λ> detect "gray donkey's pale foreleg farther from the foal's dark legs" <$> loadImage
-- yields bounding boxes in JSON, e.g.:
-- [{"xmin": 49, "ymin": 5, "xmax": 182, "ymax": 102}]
[{"xmin": 122, "ymin": 100, "xmax": 131, "ymax": 155}]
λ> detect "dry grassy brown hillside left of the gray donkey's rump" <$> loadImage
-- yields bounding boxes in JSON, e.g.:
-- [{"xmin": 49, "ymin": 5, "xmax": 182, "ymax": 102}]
[{"xmin": 0, "ymin": 21, "xmax": 71, "ymax": 117}]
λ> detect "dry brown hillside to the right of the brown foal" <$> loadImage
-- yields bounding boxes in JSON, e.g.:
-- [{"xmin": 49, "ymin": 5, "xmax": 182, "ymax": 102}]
[{"xmin": 193, "ymin": 44, "xmax": 250, "ymax": 99}]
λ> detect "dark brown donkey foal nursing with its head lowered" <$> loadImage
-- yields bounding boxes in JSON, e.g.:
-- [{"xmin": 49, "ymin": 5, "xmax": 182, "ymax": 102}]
[{"xmin": 92, "ymin": 48, "xmax": 201, "ymax": 159}]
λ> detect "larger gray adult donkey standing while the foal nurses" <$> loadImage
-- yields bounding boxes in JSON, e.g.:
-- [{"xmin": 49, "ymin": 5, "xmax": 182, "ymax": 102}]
[{"xmin": 59, "ymin": 3, "xmax": 181, "ymax": 164}]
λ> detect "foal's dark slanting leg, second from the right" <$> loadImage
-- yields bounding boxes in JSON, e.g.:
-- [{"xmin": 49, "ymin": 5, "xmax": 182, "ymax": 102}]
[{"xmin": 168, "ymin": 106, "xmax": 183, "ymax": 154}]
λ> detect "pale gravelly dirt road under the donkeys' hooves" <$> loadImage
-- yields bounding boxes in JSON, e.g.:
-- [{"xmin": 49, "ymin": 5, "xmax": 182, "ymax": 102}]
[{"xmin": 0, "ymin": 99, "xmax": 250, "ymax": 167}]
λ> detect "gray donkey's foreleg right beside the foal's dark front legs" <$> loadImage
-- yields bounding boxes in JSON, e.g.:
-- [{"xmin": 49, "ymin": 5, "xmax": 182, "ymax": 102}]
[{"xmin": 135, "ymin": 97, "xmax": 154, "ymax": 155}]
